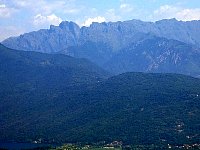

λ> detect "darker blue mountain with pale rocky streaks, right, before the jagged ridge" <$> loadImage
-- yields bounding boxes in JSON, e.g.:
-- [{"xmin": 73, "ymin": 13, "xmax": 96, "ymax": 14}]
[{"xmin": 103, "ymin": 37, "xmax": 200, "ymax": 76}]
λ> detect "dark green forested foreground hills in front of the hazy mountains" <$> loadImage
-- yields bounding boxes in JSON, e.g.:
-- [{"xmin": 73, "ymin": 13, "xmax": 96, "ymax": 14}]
[{"xmin": 0, "ymin": 45, "xmax": 200, "ymax": 145}]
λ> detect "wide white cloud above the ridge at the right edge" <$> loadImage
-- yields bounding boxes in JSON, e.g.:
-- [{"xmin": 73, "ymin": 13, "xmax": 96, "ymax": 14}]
[{"xmin": 151, "ymin": 5, "xmax": 200, "ymax": 21}]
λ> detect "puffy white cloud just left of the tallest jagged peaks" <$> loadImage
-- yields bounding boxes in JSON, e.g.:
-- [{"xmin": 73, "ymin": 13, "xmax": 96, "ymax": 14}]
[{"xmin": 33, "ymin": 14, "xmax": 62, "ymax": 26}]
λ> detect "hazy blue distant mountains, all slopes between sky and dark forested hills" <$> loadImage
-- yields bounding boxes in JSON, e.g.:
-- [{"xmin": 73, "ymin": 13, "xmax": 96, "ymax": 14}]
[{"xmin": 2, "ymin": 19, "xmax": 200, "ymax": 76}]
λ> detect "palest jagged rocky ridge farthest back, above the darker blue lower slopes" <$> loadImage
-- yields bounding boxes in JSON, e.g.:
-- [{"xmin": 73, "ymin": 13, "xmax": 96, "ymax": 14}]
[{"xmin": 2, "ymin": 19, "xmax": 200, "ymax": 53}]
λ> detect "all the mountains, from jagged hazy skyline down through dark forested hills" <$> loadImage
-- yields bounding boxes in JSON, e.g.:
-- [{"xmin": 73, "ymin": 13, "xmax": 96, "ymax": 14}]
[{"xmin": 0, "ymin": 19, "xmax": 200, "ymax": 146}]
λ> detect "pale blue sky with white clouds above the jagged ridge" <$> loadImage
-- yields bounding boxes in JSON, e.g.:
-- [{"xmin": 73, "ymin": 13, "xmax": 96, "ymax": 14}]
[{"xmin": 0, "ymin": 0, "xmax": 200, "ymax": 41}]
